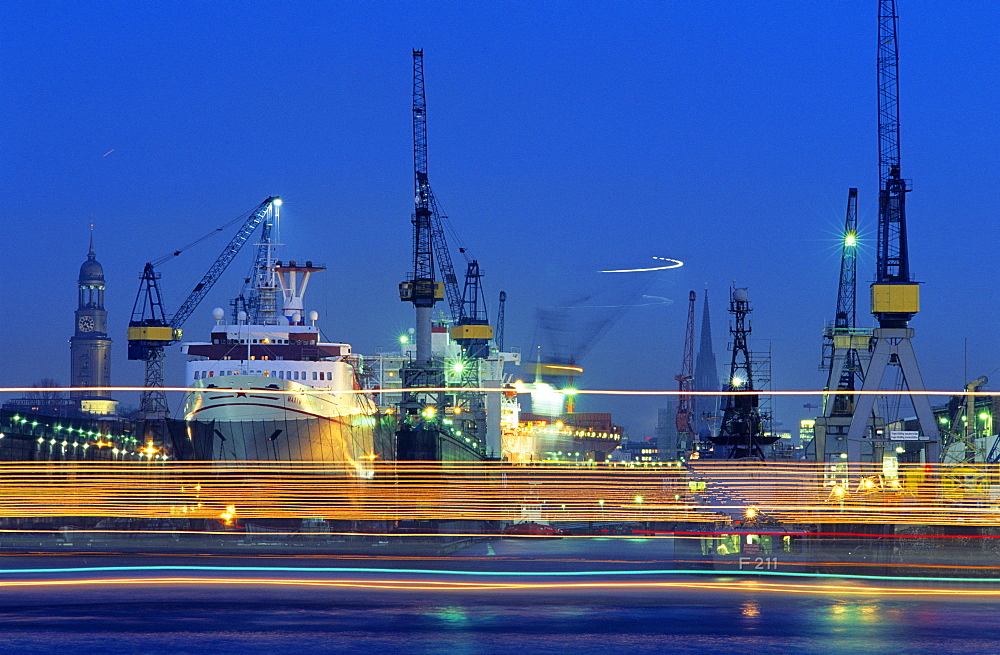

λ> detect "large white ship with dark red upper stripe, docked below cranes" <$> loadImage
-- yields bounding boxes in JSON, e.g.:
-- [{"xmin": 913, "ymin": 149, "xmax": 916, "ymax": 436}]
[{"xmin": 182, "ymin": 256, "xmax": 392, "ymax": 478}]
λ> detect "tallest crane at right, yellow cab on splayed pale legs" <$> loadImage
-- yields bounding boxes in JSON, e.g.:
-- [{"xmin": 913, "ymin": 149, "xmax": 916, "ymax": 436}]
[{"xmin": 847, "ymin": 0, "xmax": 940, "ymax": 462}]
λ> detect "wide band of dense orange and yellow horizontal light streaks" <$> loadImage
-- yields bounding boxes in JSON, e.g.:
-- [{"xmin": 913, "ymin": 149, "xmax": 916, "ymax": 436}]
[{"xmin": 0, "ymin": 461, "xmax": 1000, "ymax": 528}]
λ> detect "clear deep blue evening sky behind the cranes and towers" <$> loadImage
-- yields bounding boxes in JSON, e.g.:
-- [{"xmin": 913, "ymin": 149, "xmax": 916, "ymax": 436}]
[{"xmin": 0, "ymin": 0, "xmax": 1000, "ymax": 438}]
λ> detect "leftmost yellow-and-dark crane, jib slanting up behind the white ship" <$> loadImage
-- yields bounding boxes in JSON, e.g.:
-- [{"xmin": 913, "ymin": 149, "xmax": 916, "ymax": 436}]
[{"xmin": 128, "ymin": 196, "xmax": 281, "ymax": 419}]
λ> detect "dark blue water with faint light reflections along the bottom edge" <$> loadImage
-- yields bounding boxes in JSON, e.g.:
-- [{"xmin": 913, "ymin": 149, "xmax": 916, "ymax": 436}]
[{"xmin": 0, "ymin": 592, "xmax": 1000, "ymax": 654}]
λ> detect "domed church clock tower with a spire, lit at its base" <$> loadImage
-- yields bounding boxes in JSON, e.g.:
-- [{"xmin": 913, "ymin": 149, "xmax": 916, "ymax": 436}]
[{"xmin": 69, "ymin": 227, "xmax": 117, "ymax": 414}]
